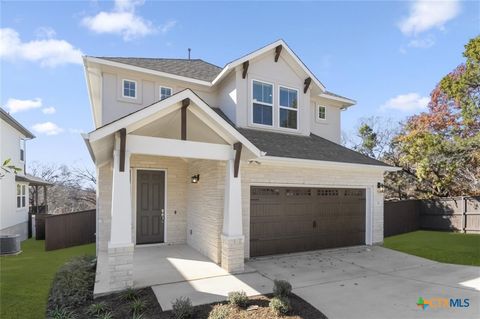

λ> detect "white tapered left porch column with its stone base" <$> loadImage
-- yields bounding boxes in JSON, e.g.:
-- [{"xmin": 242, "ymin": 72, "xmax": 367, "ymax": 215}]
[{"xmin": 108, "ymin": 133, "xmax": 133, "ymax": 291}]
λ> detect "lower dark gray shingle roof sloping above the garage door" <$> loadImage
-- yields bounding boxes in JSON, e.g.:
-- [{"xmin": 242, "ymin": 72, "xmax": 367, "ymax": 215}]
[{"xmin": 213, "ymin": 108, "xmax": 390, "ymax": 167}]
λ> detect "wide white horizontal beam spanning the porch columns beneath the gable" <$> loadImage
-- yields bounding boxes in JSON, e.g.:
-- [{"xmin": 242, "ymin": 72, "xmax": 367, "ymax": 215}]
[{"xmin": 126, "ymin": 134, "xmax": 235, "ymax": 161}]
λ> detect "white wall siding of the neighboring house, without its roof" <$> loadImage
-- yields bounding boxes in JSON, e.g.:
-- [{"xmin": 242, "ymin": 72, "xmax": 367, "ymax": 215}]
[{"xmin": 0, "ymin": 120, "xmax": 29, "ymax": 240}]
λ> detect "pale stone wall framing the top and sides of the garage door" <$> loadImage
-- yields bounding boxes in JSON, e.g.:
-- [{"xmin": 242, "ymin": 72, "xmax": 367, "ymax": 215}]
[{"xmin": 241, "ymin": 163, "xmax": 383, "ymax": 258}]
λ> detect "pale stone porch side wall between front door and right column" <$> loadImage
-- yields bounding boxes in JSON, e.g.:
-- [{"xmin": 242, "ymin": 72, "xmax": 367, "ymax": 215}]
[{"xmin": 187, "ymin": 160, "xmax": 226, "ymax": 263}]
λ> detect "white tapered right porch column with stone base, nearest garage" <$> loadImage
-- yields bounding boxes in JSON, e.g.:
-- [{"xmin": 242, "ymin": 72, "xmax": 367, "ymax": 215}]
[{"xmin": 222, "ymin": 160, "xmax": 245, "ymax": 273}]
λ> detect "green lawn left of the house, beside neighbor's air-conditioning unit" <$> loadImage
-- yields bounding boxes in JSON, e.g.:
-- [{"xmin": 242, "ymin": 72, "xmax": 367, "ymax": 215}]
[{"xmin": 0, "ymin": 239, "xmax": 95, "ymax": 319}]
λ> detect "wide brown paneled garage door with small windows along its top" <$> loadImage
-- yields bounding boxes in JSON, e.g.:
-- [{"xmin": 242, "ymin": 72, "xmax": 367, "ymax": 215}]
[{"xmin": 250, "ymin": 186, "xmax": 365, "ymax": 257}]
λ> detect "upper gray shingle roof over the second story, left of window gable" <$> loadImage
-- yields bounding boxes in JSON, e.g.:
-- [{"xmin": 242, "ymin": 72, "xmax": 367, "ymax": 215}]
[{"xmin": 97, "ymin": 57, "xmax": 222, "ymax": 82}]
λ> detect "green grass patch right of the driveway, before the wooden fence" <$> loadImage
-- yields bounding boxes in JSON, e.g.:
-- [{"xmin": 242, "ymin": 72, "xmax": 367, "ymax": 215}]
[{"xmin": 384, "ymin": 230, "xmax": 480, "ymax": 266}]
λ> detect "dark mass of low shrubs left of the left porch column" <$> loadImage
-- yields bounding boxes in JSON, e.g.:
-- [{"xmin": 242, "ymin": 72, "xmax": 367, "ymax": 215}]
[{"xmin": 49, "ymin": 256, "xmax": 96, "ymax": 309}]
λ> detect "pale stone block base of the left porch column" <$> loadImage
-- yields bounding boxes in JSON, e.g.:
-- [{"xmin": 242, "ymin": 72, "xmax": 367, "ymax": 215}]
[{"xmin": 108, "ymin": 243, "xmax": 133, "ymax": 291}]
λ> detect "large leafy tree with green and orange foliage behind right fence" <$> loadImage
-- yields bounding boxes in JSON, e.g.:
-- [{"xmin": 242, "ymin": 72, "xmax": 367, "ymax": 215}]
[{"xmin": 393, "ymin": 37, "xmax": 480, "ymax": 198}]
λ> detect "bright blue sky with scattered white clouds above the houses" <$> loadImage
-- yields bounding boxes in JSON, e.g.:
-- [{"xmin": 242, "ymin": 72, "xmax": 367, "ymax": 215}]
[{"xmin": 0, "ymin": 0, "xmax": 480, "ymax": 172}]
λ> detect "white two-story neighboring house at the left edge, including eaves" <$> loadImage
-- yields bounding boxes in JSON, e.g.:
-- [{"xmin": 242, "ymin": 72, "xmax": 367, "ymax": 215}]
[{"xmin": 0, "ymin": 108, "xmax": 39, "ymax": 240}]
